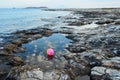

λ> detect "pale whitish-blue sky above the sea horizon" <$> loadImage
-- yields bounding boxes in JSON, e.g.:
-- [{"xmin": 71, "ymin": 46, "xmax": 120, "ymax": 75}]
[{"xmin": 0, "ymin": 0, "xmax": 120, "ymax": 8}]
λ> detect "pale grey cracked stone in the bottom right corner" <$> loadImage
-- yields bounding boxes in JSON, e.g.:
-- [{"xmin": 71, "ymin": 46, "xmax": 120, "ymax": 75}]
[{"xmin": 91, "ymin": 67, "xmax": 120, "ymax": 80}]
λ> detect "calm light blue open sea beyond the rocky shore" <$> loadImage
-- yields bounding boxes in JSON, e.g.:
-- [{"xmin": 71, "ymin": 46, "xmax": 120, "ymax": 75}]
[{"xmin": 0, "ymin": 8, "xmax": 69, "ymax": 33}]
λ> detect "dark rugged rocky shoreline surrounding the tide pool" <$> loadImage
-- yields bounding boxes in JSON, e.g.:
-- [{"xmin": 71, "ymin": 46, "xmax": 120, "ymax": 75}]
[{"xmin": 0, "ymin": 9, "xmax": 120, "ymax": 80}]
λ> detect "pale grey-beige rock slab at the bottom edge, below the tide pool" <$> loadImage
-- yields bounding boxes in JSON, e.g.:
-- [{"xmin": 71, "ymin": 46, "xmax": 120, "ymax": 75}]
[{"xmin": 20, "ymin": 68, "xmax": 71, "ymax": 80}]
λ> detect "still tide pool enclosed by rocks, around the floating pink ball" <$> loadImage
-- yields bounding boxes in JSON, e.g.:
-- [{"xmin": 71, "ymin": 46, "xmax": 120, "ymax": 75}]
[{"xmin": 19, "ymin": 33, "xmax": 72, "ymax": 70}]
